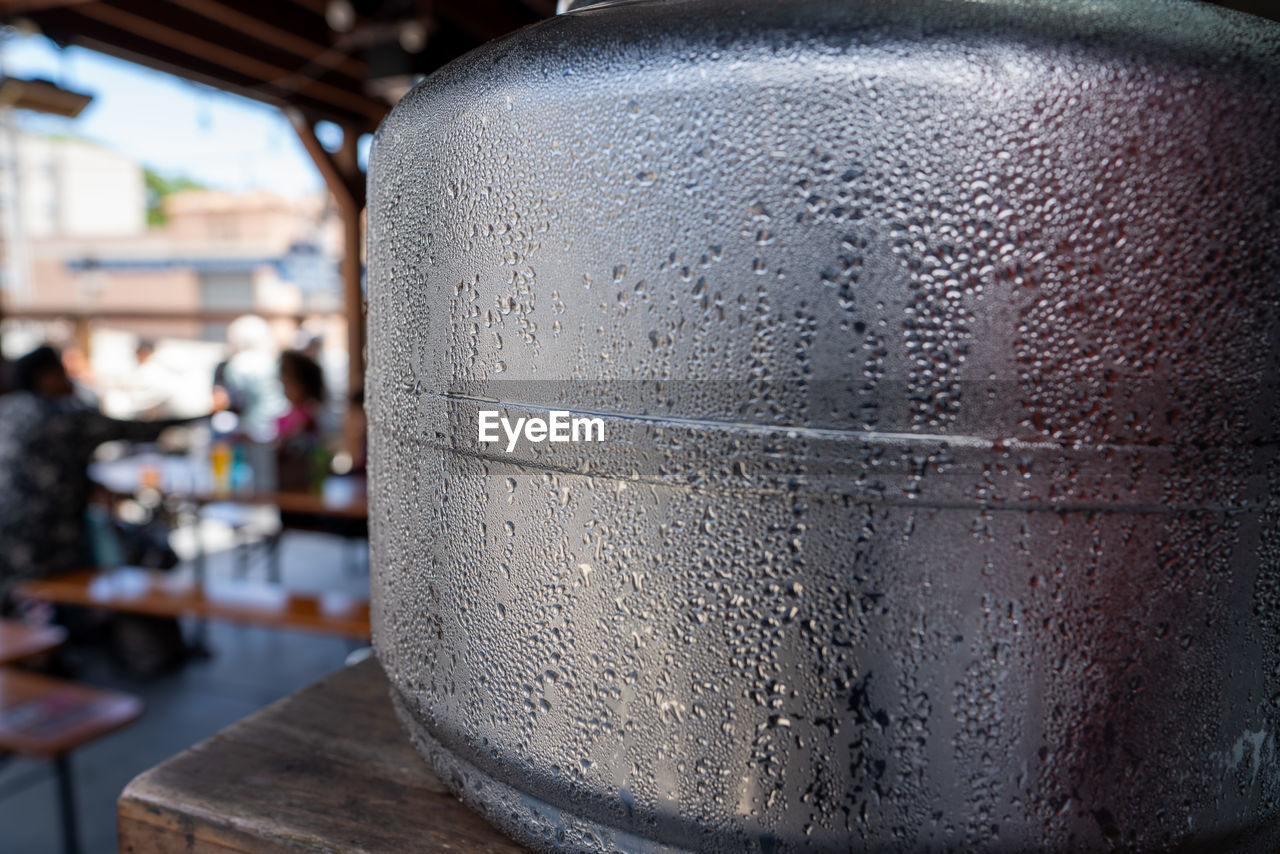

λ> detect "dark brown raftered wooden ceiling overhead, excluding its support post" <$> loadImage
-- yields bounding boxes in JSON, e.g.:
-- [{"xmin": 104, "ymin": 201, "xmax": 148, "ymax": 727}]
[{"xmin": 0, "ymin": 0, "xmax": 553, "ymax": 133}]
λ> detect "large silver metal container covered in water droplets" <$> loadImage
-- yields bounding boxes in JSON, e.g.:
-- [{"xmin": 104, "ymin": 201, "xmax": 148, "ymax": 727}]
[{"xmin": 369, "ymin": 0, "xmax": 1280, "ymax": 851}]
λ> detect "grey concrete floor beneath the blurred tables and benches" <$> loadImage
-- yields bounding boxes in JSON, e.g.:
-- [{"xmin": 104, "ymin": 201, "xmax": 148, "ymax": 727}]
[{"xmin": 0, "ymin": 531, "xmax": 369, "ymax": 854}]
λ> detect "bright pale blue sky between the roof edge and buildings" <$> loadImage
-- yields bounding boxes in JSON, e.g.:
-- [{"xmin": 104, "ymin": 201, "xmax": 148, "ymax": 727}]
[{"xmin": 3, "ymin": 36, "xmax": 335, "ymax": 196}]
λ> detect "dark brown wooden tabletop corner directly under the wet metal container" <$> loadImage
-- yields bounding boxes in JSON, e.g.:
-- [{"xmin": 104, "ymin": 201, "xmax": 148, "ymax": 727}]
[{"xmin": 119, "ymin": 659, "xmax": 525, "ymax": 854}]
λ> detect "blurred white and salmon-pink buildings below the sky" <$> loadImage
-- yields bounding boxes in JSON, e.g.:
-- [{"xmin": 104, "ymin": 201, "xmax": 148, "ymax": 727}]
[{"xmin": 0, "ymin": 133, "xmax": 342, "ymax": 341}]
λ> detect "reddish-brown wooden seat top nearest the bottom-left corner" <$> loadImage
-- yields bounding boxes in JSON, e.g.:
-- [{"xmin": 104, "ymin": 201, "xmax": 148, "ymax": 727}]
[{"xmin": 0, "ymin": 667, "xmax": 142, "ymax": 759}]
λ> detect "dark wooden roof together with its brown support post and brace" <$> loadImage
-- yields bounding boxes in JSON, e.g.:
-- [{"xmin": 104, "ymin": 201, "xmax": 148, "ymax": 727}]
[{"xmin": 0, "ymin": 0, "xmax": 556, "ymax": 407}]
